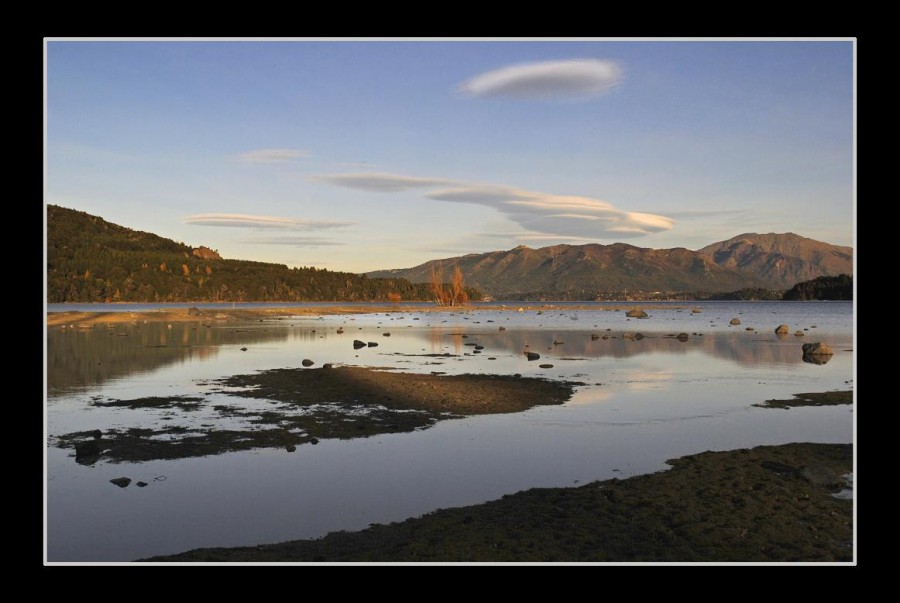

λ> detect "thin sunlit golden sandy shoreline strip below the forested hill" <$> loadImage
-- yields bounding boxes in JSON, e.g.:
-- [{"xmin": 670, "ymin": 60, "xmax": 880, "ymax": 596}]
[{"xmin": 46, "ymin": 302, "xmax": 693, "ymax": 327}]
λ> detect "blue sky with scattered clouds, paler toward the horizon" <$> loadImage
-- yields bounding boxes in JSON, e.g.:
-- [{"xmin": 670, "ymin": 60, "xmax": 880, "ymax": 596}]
[{"xmin": 44, "ymin": 38, "xmax": 856, "ymax": 272}]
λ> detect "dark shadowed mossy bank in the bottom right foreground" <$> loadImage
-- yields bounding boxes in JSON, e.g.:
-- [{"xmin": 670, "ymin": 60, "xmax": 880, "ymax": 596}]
[{"xmin": 145, "ymin": 443, "xmax": 853, "ymax": 562}]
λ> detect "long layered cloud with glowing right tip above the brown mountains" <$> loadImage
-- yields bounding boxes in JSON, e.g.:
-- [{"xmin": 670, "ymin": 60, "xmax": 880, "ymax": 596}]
[{"xmin": 314, "ymin": 173, "xmax": 675, "ymax": 240}]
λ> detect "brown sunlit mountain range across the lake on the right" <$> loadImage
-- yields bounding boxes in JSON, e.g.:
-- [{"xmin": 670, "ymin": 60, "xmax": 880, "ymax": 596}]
[{"xmin": 368, "ymin": 233, "xmax": 853, "ymax": 301}]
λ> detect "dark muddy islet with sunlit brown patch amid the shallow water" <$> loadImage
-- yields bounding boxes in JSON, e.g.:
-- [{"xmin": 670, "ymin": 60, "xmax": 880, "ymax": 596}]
[{"xmin": 57, "ymin": 366, "xmax": 579, "ymax": 464}]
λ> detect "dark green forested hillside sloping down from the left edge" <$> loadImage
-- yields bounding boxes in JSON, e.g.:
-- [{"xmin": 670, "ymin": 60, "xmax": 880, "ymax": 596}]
[{"xmin": 47, "ymin": 205, "xmax": 481, "ymax": 303}]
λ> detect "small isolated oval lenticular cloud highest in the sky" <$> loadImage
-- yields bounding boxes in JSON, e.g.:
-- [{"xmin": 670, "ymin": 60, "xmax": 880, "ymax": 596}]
[{"xmin": 459, "ymin": 59, "xmax": 622, "ymax": 100}]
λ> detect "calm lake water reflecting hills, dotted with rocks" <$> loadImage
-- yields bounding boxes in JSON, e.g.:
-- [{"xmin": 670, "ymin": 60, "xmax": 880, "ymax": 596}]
[{"xmin": 45, "ymin": 302, "xmax": 855, "ymax": 562}]
